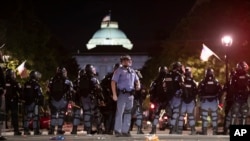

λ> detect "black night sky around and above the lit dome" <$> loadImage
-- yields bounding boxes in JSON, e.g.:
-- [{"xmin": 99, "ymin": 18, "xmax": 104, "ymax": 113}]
[{"xmin": 34, "ymin": 0, "xmax": 195, "ymax": 51}]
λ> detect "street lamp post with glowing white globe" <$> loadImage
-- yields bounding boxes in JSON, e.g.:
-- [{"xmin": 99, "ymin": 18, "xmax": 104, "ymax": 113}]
[{"xmin": 221, "ymin": 35, "xmax": 233, "ymax": 83}]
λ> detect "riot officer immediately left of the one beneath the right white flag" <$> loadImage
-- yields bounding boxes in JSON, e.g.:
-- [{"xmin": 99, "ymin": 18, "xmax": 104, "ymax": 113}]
[{"xmin": 178, "ymin": 67, "xmax": 197, "ymax": 135}]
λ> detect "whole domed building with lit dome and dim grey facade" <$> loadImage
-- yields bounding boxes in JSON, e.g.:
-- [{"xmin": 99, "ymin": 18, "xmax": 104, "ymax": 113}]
[{"xmin": 74, "ymin": 16, "xmax": 148, "ymax": 79}]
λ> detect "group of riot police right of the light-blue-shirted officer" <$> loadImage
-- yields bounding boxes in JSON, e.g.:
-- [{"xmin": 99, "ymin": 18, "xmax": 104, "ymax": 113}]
[{"xmin": 150, "ymin": 61, "xmax": 250, "ymax": 135}]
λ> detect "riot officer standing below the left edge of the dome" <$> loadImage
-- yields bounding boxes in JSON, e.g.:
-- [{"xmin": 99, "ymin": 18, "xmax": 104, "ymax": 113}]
[{"xmin": 78, "ymin": 64, "xmax": 104, "ymax": 135}]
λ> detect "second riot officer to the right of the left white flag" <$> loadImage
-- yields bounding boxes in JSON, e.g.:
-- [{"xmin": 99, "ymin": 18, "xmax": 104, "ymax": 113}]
[{"xmin": 48, "ymin": 67, "xmax": 73, "ymax": 135}]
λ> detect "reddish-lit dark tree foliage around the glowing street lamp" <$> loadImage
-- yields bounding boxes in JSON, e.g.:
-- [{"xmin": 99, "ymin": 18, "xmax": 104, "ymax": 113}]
[{"xmin": 142, "ymin": 0, "xmax": 250, "ymax": 86}]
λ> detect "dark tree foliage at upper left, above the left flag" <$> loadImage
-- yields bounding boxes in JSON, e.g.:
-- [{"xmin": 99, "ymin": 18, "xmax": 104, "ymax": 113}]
[{"xmin": 0, "ymin": 0, "xmax": 78, "ymax": 86}]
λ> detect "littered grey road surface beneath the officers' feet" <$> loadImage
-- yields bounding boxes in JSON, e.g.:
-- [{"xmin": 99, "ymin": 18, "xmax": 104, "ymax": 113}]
[{"xmin": 0, "ymin": 127, "xmax": 229, "ymax": 141}]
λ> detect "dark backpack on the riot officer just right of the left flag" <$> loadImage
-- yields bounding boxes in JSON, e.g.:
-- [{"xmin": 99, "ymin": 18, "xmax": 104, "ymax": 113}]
[{"xmin": 23, "ymin": 81, "xmax": 36, "ymax": 105}]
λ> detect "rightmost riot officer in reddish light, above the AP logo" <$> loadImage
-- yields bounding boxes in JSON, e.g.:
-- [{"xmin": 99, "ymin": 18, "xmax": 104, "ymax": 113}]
[{"xmin": 231, "ymin": 61, "xmax": 250, "ymax": 125}]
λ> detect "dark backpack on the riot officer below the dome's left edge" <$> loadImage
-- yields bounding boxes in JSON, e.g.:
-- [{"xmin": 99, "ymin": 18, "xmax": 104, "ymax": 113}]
[{"xmin": 78, "ymin": 75, "xmax": 91, "ymax": 97}]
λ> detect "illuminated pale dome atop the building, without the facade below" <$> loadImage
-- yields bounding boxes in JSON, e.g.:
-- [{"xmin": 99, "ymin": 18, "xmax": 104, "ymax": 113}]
[{"xmin": 86, "ymin": 21, "xmax": 133, "ymax": 50}]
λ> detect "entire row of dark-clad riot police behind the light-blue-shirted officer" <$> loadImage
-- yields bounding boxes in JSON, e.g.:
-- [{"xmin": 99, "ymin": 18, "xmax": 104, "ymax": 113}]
[{"xmin": 0, "ymin": 61, "xmax": 250, "ymax": 138}]
